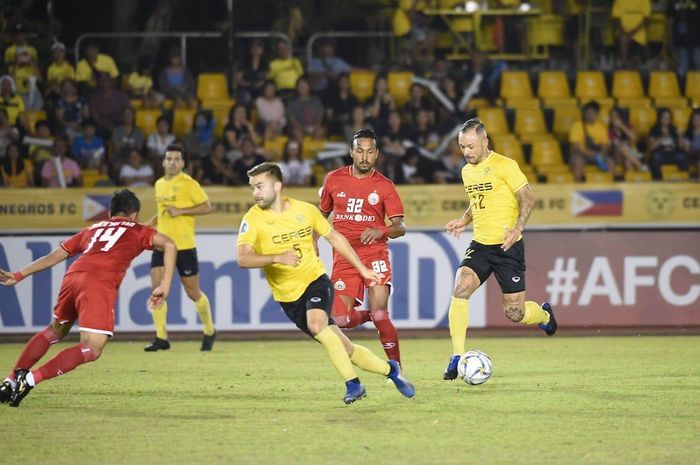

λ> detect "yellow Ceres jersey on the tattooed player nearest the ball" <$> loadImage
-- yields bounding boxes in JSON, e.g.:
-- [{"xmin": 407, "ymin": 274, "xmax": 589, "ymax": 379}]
[{"xmin": 462, "ymin": 151, "xmax": 527, "ymax": 245}]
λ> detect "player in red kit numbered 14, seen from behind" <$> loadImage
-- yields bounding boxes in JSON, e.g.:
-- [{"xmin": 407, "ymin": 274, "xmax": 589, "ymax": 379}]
[{"xmin": 0, "ymin": 189, "xmax": 177, "ymax": 407}]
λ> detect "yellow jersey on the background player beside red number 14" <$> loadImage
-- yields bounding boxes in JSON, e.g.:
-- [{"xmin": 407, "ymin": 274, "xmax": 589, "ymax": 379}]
[{"xmin": 156, "ymin": 173, "xmax": 209, "ymax": 250}]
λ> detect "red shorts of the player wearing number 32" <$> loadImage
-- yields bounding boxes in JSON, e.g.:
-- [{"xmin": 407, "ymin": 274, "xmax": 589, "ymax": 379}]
[{"xmin": 331, "ymin": 247, "xmax": 391, "ymax": 306}]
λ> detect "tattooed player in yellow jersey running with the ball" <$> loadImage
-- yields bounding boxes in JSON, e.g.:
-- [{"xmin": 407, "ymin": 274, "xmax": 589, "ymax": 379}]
[{"xmin": 442, "ymin": 118, "xmax": 557, "ymax": 379}]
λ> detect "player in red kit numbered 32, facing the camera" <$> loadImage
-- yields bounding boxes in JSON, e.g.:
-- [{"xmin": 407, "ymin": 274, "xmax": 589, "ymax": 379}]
[{"xmin": 319, "ymin": 129, "xmax": 406, "ymax": 363}]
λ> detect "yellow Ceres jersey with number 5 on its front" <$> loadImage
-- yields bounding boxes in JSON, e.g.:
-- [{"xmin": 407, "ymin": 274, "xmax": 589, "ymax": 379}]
[{"xmin": 237, "ymin": 197, "xmax": 331, "ymax": 302}]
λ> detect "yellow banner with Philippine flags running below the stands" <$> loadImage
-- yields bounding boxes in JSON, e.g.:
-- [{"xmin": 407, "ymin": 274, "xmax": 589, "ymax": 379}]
[{"xmin": 0, "ymin": 183, "xmax": 700, "ymax": 232}]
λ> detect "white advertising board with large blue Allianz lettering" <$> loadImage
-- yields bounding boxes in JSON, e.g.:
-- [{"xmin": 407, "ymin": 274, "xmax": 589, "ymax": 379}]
[{"xmin": 0, "ymin": 232, "xmax": 485, "ymax": 334}]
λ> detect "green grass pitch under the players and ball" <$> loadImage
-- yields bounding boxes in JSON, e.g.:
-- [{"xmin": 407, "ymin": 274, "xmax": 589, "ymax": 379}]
[{"xmin": 0, "ymin": 333, "xmax": 700, "ymax": 465}]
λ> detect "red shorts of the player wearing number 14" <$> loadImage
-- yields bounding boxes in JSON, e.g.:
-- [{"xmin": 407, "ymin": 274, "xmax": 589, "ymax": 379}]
[{"xmin": 53, "ymin": 272, "xmax": 117, "ymax": 337}]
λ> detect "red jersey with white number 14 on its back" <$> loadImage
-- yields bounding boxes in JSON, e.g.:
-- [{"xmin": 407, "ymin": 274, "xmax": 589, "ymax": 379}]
[{"xmin": 61, "ymin": 217, "xmax": 157, "ymax": 288}]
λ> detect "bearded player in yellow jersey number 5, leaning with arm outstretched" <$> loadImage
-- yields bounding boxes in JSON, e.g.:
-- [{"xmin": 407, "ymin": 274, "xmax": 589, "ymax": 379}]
[{"xmin": 237, "ymin": 163, "xmax": 415, "ymax": 404}]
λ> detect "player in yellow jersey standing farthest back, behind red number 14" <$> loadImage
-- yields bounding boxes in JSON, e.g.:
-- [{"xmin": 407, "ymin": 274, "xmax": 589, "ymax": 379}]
[{"xmin": 144, "ymin": 144, "xmax": 216, "ymax": 352}]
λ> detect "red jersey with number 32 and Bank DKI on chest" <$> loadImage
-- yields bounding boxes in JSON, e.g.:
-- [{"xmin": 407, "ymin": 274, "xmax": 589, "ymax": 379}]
[{"xmin": 319, "ymin": 166, "xmax": 403, "ymax": 249}]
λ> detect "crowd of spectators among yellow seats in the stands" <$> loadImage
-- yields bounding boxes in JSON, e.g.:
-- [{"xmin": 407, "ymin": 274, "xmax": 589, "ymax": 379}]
[{"xmin": 0, "ymin": 1, "xmax": 700, "ymax": 188}]
